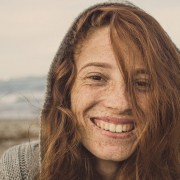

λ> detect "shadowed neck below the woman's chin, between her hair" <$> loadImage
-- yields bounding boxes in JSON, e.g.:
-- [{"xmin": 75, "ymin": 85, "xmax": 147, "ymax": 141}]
[{"xmin": 96, "ymin": 159, "xmax": 118, "ymax": 180}]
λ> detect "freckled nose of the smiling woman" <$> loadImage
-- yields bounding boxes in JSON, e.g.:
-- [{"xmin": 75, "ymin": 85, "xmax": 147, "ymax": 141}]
[{"xmin": 104, "ymin": 82, "xmax": 131, "ymax": 112}]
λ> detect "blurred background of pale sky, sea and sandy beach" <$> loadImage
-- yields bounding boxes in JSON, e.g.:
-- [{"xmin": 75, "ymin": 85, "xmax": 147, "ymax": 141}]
[{"xmin": 0, "ymin": 0, "xmax": 180, "ymax": 155}]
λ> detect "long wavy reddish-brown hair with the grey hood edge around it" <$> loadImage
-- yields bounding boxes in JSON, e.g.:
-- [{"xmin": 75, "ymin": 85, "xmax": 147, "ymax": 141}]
[{"xmin": 39, "ymin": 3, "xmax": 180, "ymax": 180}]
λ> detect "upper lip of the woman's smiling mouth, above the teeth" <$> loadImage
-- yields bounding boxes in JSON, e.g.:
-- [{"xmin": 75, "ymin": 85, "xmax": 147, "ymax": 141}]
[{"xmin": 90, "ymin": 116, "xmax": 135, "ymax": 124}]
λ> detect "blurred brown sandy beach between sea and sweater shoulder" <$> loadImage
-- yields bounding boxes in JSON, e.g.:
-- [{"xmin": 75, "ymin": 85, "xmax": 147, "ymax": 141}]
[{"xmin": 0, "ymin": 119, "xmax": 39, "ymax": 156}]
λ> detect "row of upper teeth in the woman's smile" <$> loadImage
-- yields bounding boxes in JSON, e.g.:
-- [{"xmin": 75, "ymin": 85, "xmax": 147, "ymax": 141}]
[{"xmin": 96, "ymin": 121, "xmax": 134, "ymax": 133}]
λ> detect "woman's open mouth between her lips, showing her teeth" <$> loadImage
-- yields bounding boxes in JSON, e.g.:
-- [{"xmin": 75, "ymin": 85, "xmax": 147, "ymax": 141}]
[{"xmin": 91, "ymin": 118, "xmax": 135, "ymax": 133}]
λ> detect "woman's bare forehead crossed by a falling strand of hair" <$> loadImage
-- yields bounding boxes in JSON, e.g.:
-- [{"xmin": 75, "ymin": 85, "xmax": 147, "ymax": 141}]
[{"xmin": 75, "ymin": 26, "xmax": 143, "ymax": 69}]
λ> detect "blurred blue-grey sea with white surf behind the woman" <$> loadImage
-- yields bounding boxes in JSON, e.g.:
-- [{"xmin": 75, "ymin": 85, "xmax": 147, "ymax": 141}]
[{"xmin": 0, "ymin": 76, "xmax": 46, "ymax": 119}]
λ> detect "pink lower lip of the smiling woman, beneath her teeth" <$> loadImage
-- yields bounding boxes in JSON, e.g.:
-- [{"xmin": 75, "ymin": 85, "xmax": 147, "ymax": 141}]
[{"xmin": 91, "ymin": 121, "xmax": 135, "ymax": 139}]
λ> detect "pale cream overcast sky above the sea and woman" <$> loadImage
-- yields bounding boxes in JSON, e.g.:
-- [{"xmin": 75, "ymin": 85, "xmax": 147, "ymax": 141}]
[{"xmin": 0, "ymin": 0, "xmax": 180, "ymax": 80}]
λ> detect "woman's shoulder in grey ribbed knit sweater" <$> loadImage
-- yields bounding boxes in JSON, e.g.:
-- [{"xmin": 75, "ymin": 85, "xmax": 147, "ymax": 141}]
[{"xmin": 0, "ymin": 141, "xmax": 39, "ymax": 179}]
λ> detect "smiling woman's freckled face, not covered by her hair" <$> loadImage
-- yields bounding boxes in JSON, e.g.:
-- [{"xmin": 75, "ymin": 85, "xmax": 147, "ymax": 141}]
[{"xmin": 71, "ymin": 27, "xmax": 147, "ymax": 161}]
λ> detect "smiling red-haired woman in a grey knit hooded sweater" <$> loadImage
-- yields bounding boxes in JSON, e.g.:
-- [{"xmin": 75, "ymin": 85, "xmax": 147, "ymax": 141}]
[{"xmin": 1, "ymin": 0, "xmax": 180, "ymax": 180}]
